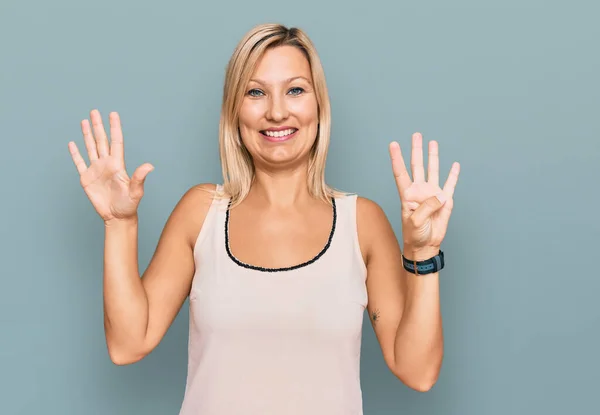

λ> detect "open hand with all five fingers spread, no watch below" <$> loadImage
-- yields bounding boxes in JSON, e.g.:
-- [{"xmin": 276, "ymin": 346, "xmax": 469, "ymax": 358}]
[{"xmin": 69, "ymin": 110, "xmax": 154, "ymax": 224}]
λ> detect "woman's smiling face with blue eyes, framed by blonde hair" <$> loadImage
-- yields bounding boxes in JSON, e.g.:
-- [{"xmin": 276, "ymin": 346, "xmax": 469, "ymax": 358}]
[{"xmin": 239, "ymin": 46, "xmax": 319, "ymax": 169}]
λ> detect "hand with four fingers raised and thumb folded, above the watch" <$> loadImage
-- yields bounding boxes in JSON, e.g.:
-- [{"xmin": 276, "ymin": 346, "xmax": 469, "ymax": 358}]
[{"xmin": 390, "ymin": 133, "xmax": 460, "ymax": 261}]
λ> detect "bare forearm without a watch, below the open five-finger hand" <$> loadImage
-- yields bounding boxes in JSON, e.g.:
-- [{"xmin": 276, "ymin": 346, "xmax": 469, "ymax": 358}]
[{"xmin": 104, "ymin": 218, "xmax": 148, "ymax": 360}]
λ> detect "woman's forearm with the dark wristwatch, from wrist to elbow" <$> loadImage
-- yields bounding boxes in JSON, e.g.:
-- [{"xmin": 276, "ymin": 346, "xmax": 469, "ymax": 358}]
[{"xmin": 394, "ymin": 245, "xmax": 444, "ymax": 390}]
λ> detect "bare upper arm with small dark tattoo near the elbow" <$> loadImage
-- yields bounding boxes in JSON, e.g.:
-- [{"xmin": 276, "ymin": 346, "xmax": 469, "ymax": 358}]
[{"xmin": 357, "ymin": 197, "xmax": 406, "ymax": 371}]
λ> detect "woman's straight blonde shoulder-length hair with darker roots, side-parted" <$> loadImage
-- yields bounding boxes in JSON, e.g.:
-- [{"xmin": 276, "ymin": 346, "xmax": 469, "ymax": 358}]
[{"xmin": 217, "ymin": 24, "xmax": 341, "ymax": 207}]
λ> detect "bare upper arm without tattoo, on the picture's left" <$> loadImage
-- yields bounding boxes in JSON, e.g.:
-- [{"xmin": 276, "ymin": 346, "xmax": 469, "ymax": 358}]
[{"xmin": 142, "ymin": 184, "xmax": 215, "ymax": 353}]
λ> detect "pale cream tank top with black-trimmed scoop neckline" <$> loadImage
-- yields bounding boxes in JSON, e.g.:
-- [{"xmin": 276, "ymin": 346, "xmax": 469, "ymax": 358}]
[{"xmin": 179, "ymin": 186, "xmax": 367, "ymax": 415}]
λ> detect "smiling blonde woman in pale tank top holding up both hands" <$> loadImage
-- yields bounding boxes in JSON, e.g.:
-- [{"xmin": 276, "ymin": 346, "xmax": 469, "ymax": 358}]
[{"xmin": 69, "ymin": 25, "xmax": 459, "ymax": 415}]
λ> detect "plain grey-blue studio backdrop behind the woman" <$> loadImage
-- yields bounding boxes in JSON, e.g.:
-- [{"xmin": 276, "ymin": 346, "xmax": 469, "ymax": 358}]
[{"xmin": 0, "ymin": 0, "xmax": 600, "ymax": 415}]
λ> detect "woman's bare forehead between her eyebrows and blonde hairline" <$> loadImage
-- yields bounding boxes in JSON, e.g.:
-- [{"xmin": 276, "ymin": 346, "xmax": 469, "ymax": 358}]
[{"xmin": 252, "ymin": 46, "xmax": 311, "ymax": 83}]
